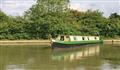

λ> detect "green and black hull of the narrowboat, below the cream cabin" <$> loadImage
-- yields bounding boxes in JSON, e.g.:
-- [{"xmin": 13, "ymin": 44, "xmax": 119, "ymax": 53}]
[{"xmin": 52, "ymin": 40, "xmax": 103, "ymax": 48}]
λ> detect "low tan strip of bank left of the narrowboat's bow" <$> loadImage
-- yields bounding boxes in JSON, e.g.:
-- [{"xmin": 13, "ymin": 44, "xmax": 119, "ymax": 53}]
[{"xmin": 0, "ymin": 40, "xmax": 50, "ymax": 46}]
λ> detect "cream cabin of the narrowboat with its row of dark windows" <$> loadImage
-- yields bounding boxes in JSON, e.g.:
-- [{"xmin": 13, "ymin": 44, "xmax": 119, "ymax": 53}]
[{"xmin": 56, "ymin": 35, "xmax": 100, "ymax": 41}]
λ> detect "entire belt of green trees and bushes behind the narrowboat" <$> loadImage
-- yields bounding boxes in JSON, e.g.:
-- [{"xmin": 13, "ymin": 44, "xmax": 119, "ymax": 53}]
[{"xmin": 0, "ymin": 0, "xmax": 120, "ymax": 40}]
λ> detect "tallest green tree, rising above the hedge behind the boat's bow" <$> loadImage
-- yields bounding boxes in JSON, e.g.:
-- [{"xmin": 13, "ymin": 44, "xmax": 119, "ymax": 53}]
[{"xmin": 25, "ymin": 0, "xmax": 69, "ymax": 38}]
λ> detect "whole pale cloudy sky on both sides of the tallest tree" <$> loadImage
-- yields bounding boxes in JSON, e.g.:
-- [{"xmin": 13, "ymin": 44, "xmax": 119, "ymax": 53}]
[{"xmin": 0, "ymin": 0, "xmax": 120, "ymax": 17}]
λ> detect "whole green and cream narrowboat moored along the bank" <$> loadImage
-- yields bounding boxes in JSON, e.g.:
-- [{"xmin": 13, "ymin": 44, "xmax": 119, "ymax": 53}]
[{"xmin": 51, "ymin": 35, "xmax": 103, "ymax": 48}]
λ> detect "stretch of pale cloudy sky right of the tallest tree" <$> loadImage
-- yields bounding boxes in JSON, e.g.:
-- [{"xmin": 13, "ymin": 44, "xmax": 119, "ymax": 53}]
[{"xmin": 71, "ymin": 0, "xmax": 120, "ymax": 17}]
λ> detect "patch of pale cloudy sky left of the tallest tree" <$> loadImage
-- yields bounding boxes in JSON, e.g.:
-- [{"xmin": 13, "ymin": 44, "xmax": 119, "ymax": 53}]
[{"xmin": 1, "ymin": 0, "xmax": 35, "ymax": 15}]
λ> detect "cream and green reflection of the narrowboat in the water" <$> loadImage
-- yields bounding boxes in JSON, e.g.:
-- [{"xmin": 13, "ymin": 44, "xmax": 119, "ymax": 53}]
[{"xmin": 52, "ymin": 45, "xmax": 100, "ymax": 61}]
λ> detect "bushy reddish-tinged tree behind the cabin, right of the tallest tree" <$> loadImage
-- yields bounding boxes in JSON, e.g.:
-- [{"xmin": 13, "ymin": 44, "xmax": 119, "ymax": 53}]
[{"xmin": 71, "ymin": 10, "xmax": 105, "ymax": 35}]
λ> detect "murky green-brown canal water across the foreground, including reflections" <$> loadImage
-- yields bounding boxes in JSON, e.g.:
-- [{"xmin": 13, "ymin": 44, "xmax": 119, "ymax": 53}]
[{"xmin": 0, "ymin": 44, "xmax": 120, "ymax": 70}]
